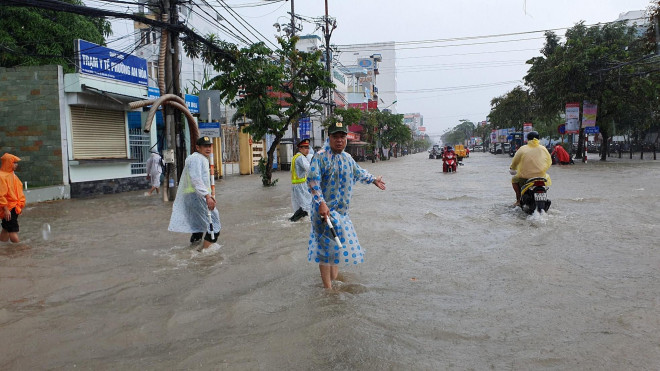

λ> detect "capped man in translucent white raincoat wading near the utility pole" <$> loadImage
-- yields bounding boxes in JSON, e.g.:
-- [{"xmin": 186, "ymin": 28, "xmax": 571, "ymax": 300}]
[{"xmin": 168, "ymin": 137, "xmax": 220, "ymax": 249}]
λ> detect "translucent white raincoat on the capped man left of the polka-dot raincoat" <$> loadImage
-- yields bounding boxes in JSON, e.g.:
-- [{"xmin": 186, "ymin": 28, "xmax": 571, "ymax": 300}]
[{"xmin": 168, "ymin": 152, "xmax": 220, "ymax": 235}]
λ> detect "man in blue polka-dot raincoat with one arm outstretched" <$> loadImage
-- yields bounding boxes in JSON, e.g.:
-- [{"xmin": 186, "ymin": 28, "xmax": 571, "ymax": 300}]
[{"xmin": 307, "ymin": 122, "xmax": 385, "ymax": 288}]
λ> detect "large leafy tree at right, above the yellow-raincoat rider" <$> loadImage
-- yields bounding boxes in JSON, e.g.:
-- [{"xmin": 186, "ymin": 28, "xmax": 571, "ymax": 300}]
[{"xmin": 524, "ymin": 23, "xmax": 660, "ymax": 161}]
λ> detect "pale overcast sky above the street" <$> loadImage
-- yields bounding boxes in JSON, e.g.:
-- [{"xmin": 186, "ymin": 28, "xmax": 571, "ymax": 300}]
[{"xmin": 104, "ymin": 0, "xmax": 651, "ymax": 134}]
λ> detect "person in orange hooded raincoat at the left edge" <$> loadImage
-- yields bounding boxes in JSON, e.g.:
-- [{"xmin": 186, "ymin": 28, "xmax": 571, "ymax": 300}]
[{"xmin": 0, "ymin": 153, "xmax": 25, "ymax": 243}]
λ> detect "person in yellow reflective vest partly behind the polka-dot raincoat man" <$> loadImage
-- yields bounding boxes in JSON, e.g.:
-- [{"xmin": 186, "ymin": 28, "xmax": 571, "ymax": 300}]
[{"xmin": 289, "ymin": 139, "xmax": 312, "ymax": 222}]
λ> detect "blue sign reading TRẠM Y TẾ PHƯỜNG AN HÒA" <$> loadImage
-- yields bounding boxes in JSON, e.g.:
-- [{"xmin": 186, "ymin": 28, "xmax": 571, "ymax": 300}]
[{"xmin": 76, "ymin": 39, "xmax": 149, "ymax": 86}]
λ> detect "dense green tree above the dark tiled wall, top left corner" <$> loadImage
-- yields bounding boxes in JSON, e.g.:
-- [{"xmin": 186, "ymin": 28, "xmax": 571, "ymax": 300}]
[{"xmin": 0, "ymin": 0, "xmax": 112, "ymax": 72}]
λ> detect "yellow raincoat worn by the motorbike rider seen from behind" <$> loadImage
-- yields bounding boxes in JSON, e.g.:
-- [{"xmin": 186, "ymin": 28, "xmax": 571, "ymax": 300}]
[{"xmin": 510, "ymin": 138, "xmax": 552, "ymax": 185}]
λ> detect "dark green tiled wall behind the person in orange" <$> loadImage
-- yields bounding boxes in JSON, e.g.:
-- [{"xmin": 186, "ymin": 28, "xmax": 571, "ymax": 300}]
[{"xmin": 0, "ymin": 65, "xmax": 63, "ymax": 187}]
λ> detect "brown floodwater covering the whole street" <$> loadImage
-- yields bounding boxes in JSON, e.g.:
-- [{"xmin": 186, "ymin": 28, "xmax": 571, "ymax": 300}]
[{"xmin": 0, "ymin": 153, "xmax": 660, "ymax": 370}]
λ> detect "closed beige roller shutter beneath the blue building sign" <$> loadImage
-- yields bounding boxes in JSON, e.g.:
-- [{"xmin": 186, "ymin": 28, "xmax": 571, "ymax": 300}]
[{"xmin": 71, "ymin": 107, "xmax": 128, "ymax": 160}]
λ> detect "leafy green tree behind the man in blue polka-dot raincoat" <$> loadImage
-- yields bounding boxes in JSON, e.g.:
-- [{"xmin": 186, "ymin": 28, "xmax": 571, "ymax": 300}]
[{"xmin": 200, "ymin": 36, "xmax": 334, "ymax": 186}]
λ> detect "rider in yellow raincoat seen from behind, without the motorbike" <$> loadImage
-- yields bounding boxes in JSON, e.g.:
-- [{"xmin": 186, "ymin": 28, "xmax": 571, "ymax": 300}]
[{"xmin": 509, "ymin": 131, "xmax": 552, "ymax": 206}]
